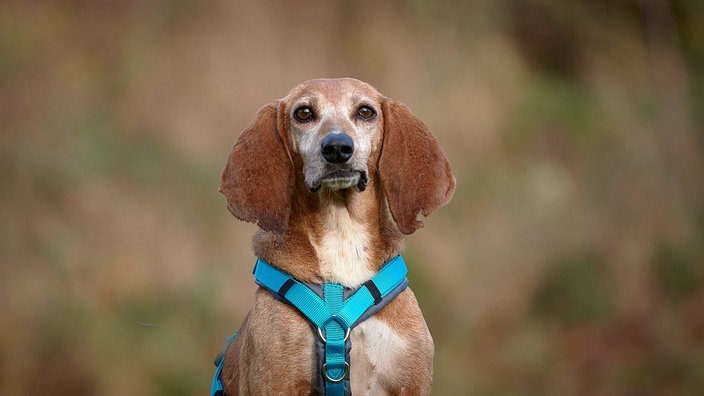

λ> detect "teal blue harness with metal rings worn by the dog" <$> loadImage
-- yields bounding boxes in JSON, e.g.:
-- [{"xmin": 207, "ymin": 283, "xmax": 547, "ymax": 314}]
[{"xmin": 210, "ymin": 256, "xmax": 408, "ymax": 396}]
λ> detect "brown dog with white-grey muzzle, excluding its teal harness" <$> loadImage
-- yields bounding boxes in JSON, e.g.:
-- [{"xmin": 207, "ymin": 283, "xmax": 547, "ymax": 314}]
[{"xmin": 219, "ymin": 78, "xmax": 456, "ymax": 396}]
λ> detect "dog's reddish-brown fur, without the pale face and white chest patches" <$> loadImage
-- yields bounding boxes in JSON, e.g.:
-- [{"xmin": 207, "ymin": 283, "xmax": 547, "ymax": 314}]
[{"xmin": 220, "ymin": 79, "xmax": 455, "ymax": 396}]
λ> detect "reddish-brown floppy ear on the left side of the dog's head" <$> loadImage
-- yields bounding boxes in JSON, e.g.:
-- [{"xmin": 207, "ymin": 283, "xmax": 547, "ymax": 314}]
[{"xmin": 218, "ymin": 103, "xmax": 293, "ymax": 233}]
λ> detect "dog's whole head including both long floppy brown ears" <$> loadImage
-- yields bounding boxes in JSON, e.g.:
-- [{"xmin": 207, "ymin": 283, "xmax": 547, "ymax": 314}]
[{"xmin": 220, "ymin": 78, "xmax": 455, "ymax": 234}]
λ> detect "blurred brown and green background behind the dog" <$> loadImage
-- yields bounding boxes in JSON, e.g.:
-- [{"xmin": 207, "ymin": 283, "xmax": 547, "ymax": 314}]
[{"xmin": 0, "ymin": 0, "xmax": 704, "ymax": 396}]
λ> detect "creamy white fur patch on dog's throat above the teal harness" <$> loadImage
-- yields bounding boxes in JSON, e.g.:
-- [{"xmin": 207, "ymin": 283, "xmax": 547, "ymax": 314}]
[{"xmin": 313, "ymin": 205, "xmax": 374, "ymax": 288}]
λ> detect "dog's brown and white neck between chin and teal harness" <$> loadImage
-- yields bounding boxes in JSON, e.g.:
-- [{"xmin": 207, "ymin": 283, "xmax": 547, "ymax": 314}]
[{"xmin": 253, "ymin": 177, "xmax": 405, "ymax": 287}]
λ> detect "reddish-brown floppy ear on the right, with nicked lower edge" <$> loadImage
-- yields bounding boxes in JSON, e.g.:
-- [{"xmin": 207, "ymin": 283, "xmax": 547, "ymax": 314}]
[{"xmin": 379, "ymin": 100, "xmax": 456, "ymax": 235}]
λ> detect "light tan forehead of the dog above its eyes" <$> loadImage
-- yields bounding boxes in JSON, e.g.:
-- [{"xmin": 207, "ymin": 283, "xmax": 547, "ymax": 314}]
[{"xmin": 282, "ymin": 78, "xmax": 383, "ymax": 103}]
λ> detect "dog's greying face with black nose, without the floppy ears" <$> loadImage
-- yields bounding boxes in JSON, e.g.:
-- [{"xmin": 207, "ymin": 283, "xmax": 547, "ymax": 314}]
[{"xmin": 279, "ymin": 79, "xmax": 383, "ymax": 192}]
